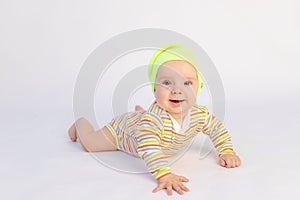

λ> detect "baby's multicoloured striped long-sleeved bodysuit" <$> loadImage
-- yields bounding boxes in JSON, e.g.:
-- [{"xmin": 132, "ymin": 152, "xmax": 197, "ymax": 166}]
[{"xmin": 106, "ymin": 101, "xmax": 234, "ymax": 180}]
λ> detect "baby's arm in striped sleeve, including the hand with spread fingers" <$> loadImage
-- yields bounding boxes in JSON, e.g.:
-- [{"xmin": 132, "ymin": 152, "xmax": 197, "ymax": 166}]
[{"xmin": 135, "ymin": 113, "xmax": 189, "ymax": 195}]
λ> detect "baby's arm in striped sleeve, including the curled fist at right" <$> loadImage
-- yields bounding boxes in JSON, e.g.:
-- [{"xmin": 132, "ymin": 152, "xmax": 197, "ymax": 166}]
[{"xmin": 202, "ymin": 110, "xmax": 241, "ymax": 168}]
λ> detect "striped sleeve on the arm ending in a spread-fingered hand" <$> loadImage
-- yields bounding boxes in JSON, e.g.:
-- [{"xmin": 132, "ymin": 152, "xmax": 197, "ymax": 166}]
[{"xmin": 136, "ymin": 113, "xmax": 171, "ymax": 180}]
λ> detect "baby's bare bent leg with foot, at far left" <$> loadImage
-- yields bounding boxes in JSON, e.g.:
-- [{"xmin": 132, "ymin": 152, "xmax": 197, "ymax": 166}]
[{"xmin": 69, "ymin": 118, "xmax": 117, "ymax": 152}]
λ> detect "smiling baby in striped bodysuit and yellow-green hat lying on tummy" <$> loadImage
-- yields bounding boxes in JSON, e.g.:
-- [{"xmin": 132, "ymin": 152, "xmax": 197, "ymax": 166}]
[{"xmin": 69, "ymin": 45, "xmax": 241, "ymax": 195}]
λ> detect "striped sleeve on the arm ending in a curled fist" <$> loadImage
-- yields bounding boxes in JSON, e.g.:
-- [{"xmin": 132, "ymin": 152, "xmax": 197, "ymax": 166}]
[{"xmin": 202, "ymin": 107, "xmax": 235, "ymax": 156}]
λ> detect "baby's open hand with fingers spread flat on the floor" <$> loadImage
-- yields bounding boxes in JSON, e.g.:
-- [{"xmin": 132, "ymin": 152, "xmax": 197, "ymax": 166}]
[{"xmin": 152, "ymin": 174, "xmax": 190, "ymax": 195}]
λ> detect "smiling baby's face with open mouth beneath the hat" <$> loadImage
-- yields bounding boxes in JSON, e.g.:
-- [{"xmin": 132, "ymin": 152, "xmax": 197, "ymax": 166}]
[{"xmin": 155, "ymin": 61, "xmax": 199, "ymax": 117}]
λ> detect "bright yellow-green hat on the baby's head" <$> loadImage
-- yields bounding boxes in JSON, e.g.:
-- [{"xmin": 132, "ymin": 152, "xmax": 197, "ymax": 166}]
[{"xmin": 148, "ymin": 44, "xmax": 203, "ymax": 95}]
